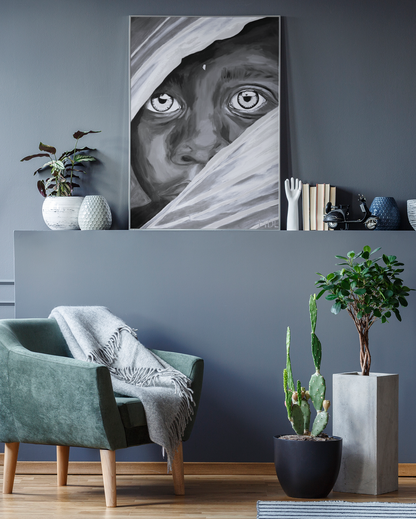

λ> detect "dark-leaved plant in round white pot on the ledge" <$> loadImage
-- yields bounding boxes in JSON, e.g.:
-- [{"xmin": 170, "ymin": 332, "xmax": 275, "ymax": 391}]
[{"xmin": 21, "ymin": 130, "xmax": 100, "ymax": 230}]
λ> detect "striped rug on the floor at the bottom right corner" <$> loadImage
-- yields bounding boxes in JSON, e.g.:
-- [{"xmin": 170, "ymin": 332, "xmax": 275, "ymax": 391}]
[{"xmin": 257, "ymin": 501, "xmax": 416, "ymax": 519}]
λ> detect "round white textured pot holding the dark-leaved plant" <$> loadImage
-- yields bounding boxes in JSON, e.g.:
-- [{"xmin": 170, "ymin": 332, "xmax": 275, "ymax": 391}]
[{"xmin": 42, "ymin": 196, "xmax": 84, "ymax": 231}]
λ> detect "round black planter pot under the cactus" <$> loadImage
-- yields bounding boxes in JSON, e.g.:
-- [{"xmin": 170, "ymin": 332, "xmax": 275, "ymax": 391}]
[{"xmin": 274, "ymin": 436, "xmax": 342, "ymax": 499}]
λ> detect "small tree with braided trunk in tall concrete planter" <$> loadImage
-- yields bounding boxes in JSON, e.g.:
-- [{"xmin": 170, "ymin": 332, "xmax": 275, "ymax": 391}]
[{"xmin": 315, "ymin": 246, "xmax": 411, "ymax": 495}]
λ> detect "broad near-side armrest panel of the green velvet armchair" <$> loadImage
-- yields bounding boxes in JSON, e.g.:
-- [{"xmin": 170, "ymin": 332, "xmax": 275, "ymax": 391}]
[{"xmin": 0, "ymin": 340, "xmax": 126, "ymax": 450}]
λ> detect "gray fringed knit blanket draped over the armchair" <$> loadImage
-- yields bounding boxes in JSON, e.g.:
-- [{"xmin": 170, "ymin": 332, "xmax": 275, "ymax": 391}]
[{"xmin": 49, "ymin": 306, "xmax": 195, "ymax": 471}]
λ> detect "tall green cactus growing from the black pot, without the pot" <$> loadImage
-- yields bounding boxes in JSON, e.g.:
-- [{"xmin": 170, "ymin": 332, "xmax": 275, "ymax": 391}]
[{"xmin": 283, "ymin": 294, "xmax": 330, "ymax": 436}]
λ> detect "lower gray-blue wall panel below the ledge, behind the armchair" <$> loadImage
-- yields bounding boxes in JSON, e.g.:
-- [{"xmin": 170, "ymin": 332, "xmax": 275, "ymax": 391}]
[{"xmin": 15, "ymin": 231, "xmax": 416, "ymax": 462}]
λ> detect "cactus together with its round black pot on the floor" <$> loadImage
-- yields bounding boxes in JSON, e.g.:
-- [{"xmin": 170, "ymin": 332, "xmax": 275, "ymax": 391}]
[{"xmin": 274, "ymin": 295, "xmax": 342, "ymax": 499}]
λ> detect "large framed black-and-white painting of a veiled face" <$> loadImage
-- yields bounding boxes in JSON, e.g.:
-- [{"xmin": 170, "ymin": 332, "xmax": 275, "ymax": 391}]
[{"xmin": 129, "ymin": 16, "xmax": 281, "ymax": 230}]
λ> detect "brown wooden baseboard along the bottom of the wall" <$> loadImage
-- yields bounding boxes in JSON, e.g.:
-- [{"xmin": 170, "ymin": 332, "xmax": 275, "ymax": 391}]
[{"xmin": 0, "ymin": 453, "xmax": 416, "ymax": 477}]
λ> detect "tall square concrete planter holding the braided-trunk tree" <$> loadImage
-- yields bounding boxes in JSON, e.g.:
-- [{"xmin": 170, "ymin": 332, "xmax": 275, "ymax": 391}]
[{"xmin": 332, "ymin": 373, "xmax": 399, "ymax": 495}]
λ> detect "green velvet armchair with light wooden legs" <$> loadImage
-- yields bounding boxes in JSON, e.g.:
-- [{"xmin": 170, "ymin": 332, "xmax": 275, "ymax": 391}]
[{"xmin": 0, "ymin": 319, "xmax": 204, "ymax": 507}]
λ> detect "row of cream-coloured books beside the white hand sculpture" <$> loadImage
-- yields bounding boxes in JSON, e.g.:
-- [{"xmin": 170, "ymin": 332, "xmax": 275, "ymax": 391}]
[{"xmin": 302, "ymin": 184, "xmax": 336, "ymax": 231}]
